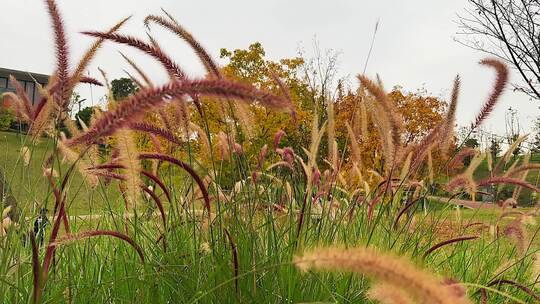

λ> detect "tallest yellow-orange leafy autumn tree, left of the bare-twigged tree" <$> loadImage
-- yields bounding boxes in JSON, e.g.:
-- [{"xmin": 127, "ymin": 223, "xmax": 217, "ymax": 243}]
[{"xmin": 209, "ymin": 42, "xmax": 311, "ymax": 152}]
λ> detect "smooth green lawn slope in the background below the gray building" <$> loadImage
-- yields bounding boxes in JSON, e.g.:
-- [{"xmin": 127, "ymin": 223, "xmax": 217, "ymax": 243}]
[{"xmin": 0, "ymin": 131, "xmax": 540, "ymax": 215}]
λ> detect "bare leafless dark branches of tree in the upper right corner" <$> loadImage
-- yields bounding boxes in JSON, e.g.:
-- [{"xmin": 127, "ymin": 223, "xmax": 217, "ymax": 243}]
[{"xmin": 459, "ymin": 0, "xmax": 540, "ymax": 100}]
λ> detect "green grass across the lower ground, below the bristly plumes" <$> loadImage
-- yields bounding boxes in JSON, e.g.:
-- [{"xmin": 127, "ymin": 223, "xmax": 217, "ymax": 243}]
[{"xmin": 0, "ymin": 132, "xmax": 540, "ymax": 303}]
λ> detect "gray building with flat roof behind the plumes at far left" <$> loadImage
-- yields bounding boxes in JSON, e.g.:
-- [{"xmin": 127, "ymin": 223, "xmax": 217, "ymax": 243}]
[{"xmin": 0, "ymin": 68, "xmax": 49, "ymax": 104}]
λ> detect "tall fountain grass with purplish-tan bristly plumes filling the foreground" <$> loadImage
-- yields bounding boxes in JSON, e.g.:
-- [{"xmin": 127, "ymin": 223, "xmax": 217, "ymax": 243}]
[{"xmin": 0, "ymin": 0, "xmax": 540, "ymax": 303}]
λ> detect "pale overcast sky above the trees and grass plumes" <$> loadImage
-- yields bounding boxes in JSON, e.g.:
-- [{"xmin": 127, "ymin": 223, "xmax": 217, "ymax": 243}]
[{"xmin": 0, "ymin": 0, "xmax": 540, "ymax": 134}]
